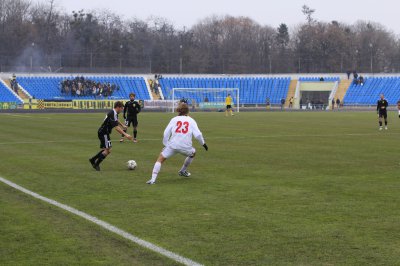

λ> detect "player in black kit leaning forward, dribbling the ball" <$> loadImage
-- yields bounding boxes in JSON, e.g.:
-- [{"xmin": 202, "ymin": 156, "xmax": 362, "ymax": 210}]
[{"xmin": 89, "ymin": 102, "xmax": 133, "ymax": 171}]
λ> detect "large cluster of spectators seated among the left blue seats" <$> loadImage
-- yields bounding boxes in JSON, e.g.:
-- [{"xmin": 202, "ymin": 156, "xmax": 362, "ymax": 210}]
[{"xmin": 60, "ymin": 77, "xmax": 119, "ymax": 97}]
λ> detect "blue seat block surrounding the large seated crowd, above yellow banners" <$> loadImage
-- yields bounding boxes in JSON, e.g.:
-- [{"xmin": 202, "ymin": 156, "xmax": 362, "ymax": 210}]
[{"xmin": 17, "ymin": 76, "xmax": 150, "ymax": 100}]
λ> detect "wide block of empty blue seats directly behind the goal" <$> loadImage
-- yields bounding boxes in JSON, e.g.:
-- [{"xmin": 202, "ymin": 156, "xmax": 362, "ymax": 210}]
[{"xmin": 160, "ymin": 78, "xmax": 290, "ymax": 104}]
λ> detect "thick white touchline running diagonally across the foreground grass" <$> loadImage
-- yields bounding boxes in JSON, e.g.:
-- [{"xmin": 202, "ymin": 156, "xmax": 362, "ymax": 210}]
[{"xmin": 0, "ymin": 177, "xmax": 202, "ymax": 266}]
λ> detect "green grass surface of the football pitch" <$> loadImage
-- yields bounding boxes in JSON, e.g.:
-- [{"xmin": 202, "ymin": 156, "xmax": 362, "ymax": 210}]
[{"xmin": 0, "ymin": 112, "xmax": 400, "ymax": 265}]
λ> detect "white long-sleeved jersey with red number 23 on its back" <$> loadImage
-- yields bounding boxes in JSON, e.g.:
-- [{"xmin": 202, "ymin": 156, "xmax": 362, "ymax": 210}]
[{"xmin": 163, "ymin": 116, "xmax": 205, "ymax": 150}]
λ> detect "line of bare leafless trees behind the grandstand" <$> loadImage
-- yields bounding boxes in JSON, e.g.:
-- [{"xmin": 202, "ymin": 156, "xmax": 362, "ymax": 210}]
[{"xmin": 0, "ymin": 0, "xmax": 400, "ymax": 74}]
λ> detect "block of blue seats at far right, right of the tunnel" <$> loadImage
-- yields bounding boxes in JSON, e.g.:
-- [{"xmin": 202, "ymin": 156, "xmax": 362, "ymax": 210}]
[{"xmin": 343, "ymin": 77, "xmax": 400, "ymax": 105}]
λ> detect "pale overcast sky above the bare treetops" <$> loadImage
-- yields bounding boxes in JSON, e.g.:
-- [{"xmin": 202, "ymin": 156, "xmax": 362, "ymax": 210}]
[{"xmin": 41, "ymin": 0, "xmax": 400, "ymax": 35}]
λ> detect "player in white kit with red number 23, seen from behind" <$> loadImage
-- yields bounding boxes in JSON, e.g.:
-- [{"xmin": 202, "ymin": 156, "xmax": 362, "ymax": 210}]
[{"xmin": 147, "ymin": 103, "xmax": 208, "ymax": 185}]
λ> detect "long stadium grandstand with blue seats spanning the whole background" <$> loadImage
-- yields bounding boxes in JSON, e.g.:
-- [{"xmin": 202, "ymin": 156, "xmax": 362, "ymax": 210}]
[{"xmin": 0, "ymin": 74, "xmax": 400, "ymax": 109}]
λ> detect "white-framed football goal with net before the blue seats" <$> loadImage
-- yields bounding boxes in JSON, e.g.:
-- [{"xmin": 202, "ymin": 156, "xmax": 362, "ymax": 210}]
[{"xmin": 170, "ymin": 88, "xmax": 240, "ymax": 112}]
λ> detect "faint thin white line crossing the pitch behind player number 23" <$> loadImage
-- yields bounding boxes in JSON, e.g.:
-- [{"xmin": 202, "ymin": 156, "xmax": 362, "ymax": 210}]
[{"xmin": 0, "ymin": 132, "xmax": 400, "ymax": 145}]
